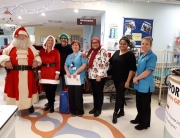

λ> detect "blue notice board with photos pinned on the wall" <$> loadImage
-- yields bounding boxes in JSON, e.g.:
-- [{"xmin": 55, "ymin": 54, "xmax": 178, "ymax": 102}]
[{"xmin": 123, "ymin": 18, "xmax": 153, "ymax": 47}]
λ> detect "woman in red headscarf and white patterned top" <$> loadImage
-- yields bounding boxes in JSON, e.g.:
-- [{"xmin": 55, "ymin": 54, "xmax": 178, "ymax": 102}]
[{"xmin": 87, "ymin": 37, "xmax": 109, "ymax": 117}]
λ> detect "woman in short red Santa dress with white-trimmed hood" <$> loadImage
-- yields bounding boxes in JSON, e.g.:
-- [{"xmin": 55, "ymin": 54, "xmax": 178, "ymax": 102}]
[{"xmin": 38, "ymin": 35, "xmax": 60, "ymax": 113}]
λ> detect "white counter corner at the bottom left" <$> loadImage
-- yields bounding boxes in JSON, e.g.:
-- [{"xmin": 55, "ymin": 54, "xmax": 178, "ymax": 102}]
[{"xmin": 0, "ymin": 105, "xmax": 19, "ymax": 138}]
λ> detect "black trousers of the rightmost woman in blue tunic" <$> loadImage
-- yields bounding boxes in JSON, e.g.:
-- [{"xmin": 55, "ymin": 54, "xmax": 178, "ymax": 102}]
[{"xmin": 135, "ymin": 91, "xmax": 152, "ymax": 127}]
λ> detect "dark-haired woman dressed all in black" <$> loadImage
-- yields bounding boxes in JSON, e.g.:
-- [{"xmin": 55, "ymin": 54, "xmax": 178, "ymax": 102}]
[{"xmin": 109, "ymin": 37, "xmax": 136, "ymax": 124}]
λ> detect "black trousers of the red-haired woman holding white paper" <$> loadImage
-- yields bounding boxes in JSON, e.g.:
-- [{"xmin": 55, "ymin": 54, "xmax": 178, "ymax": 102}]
[{"xmin": 68, "ymin": 85, "xmax": 84, "ymax": 115}]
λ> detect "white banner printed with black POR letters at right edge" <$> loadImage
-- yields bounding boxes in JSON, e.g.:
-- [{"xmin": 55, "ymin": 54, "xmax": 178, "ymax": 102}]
[{"xmin": 164, "ymin": 75, "xmax": 180, "ymax": 138}]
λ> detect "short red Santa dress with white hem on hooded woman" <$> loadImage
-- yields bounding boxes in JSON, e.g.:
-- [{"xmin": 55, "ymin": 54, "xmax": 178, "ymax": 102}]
[{"xmin": 39, "ymin": 48, "xmax": 60, "ymax": 84}]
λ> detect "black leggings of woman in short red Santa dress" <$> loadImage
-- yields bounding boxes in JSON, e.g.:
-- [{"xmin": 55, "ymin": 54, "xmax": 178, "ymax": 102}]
[{"xmin": 43, "ymin": 84, "xmax": 57, "ymax": 106}]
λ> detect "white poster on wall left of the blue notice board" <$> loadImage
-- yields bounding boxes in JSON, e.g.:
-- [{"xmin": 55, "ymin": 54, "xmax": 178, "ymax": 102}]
[{"xmin": 107, "ymin": 24, "xmax": 119, "ymax": 51}]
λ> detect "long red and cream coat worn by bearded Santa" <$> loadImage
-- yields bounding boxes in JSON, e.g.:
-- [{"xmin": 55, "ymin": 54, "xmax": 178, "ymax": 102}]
[{"xmin": 0, "ymin": 45, "xmax": 41, "ymax": 110}]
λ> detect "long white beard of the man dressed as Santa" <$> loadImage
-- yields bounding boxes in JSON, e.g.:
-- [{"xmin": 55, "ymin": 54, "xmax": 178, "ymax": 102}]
[{"xmin": 11, "ymin": 38, "xmax": 32, "ymax": 49}]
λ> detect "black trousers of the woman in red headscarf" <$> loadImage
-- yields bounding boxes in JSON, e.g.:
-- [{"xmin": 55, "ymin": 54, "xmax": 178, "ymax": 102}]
[{"xmin": 90, "ymin": 78, "xmax": 107, "ymax": 111}]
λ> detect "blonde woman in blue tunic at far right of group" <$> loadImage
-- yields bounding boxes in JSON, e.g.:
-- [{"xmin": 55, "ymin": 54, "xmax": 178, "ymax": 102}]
[{"xmin": 130, "ymin": 37, "xmax": 157, "ymax": 130}]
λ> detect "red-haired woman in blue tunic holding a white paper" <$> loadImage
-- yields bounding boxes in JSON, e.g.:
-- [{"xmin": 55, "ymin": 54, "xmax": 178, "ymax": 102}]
[{"xmin": 64, "ymin": 40, "xmax": 87, "ymax": 117}]
